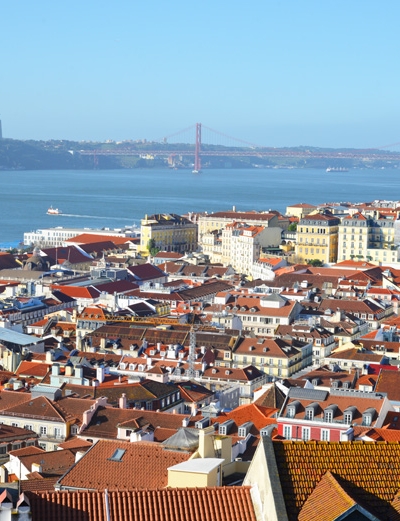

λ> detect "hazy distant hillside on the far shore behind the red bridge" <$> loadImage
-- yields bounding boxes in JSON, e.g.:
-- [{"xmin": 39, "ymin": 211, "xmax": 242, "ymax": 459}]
[{"xmin": 0, "ymin": 139, "xmax": 400, "ymax": 170}]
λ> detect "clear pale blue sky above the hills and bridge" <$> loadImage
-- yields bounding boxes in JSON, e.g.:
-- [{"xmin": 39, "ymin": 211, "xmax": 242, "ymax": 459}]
[{"xmin": 0, "ymin": 0, "xmax": 400, "ymax": 147}]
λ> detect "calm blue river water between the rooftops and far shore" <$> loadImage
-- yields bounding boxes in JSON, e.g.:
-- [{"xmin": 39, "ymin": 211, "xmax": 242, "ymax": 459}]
[{"xmin": 0, "ymin": 169, "xmax": 400, "ymax": 247}]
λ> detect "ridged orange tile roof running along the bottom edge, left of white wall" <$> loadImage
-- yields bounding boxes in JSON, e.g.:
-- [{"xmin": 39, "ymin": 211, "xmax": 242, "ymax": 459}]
[{"xmin": 29, "ymin": 487, "xmax": 256, "ymax": 521}]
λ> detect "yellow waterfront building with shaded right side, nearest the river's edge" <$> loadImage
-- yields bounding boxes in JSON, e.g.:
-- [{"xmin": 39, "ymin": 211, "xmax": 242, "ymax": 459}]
[{"xmin": 140, "ymin": 213, "xmax": 197, "ymax": 255}]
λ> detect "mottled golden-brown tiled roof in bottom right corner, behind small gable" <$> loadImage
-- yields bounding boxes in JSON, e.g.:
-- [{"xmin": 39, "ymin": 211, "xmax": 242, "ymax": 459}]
[{"xmin": 272, "ymin": 439, "xmax": 400, "ymax": 521}]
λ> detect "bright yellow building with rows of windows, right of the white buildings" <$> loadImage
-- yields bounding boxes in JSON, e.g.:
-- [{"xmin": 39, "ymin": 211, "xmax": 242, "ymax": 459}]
[{"xmin": 296, "ymin": 212, "xmax": 340, "ymax": 264}]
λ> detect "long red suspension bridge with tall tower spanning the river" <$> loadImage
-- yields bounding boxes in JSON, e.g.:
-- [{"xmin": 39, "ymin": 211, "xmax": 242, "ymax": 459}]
[{"xmin": 79, "ymin": 123, "xmax": 400, "ymax": 172}]
